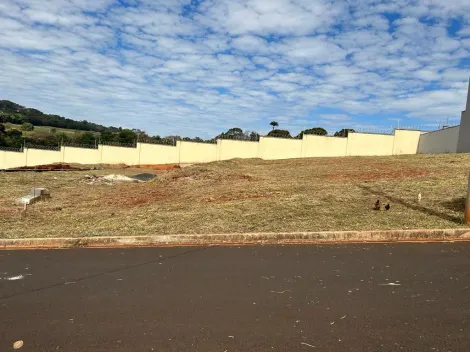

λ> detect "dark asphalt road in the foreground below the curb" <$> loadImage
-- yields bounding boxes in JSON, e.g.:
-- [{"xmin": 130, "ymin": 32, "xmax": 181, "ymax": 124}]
[{"xmin": 0, "ymin": 243, "xmax": 470, "ymax": 352}]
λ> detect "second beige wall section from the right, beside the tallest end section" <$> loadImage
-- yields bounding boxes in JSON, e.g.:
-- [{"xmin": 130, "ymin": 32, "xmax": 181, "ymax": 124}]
[{"xmin": 346, "ymin": 133, "xmax": 395, "ymax": 156}]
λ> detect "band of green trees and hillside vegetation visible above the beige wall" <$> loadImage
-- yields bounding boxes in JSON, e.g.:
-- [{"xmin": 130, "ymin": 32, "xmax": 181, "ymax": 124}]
[{"xmin": 0, "ymin": 100, "xmax": 354, "ymax": 148}]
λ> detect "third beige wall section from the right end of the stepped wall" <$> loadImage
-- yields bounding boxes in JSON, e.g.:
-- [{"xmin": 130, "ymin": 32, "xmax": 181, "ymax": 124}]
[{"xmin": 302, "ymin": 135, "xmax": 348, "ymax": 158}]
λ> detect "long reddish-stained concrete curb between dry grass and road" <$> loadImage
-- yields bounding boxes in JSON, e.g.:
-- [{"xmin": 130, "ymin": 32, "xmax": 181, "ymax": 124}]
[{"xmin": 0, "ymin": 228, "xmax": 470, "ymax": 249}]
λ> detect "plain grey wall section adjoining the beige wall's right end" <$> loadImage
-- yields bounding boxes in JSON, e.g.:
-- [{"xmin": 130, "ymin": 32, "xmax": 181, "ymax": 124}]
[{"xmin": 418, "ymin": 126, "xmax": 460, "ymax": 154}]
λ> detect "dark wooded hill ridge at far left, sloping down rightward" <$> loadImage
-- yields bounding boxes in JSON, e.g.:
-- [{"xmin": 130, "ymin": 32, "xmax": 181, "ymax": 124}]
[{"xmin": 0, "ymin": 100, "xmax": 120, "ymax": 133}]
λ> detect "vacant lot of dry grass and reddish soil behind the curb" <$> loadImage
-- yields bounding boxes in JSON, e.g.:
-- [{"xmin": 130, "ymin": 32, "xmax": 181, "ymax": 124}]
[{"xmin": 0, "ymin": 154, "xmax": 470, "ymax": 238}]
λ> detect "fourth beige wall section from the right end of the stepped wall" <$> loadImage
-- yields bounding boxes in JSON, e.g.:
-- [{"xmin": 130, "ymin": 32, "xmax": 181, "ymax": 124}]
[{"xmin": 258, "ymin": 137, "xmax": 302, "ymax": 160}]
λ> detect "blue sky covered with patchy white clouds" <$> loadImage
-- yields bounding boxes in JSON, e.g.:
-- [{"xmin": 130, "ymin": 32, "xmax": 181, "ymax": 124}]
[{"xmin": 0, "ymin": 0, "xmax": 470, "ymax": 137}]
